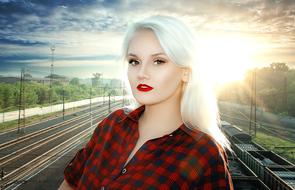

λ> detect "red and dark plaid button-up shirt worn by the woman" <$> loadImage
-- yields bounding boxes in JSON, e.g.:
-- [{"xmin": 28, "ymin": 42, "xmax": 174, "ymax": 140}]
[{"xmin": 64, "ymin": 106, "xmax": 233, "ymax": 190}]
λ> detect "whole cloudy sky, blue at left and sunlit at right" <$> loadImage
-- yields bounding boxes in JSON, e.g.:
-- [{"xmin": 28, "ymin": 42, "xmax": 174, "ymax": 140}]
[{"xmin": 0, "ymin": 0, "xmax": 295, "ymax": 81}]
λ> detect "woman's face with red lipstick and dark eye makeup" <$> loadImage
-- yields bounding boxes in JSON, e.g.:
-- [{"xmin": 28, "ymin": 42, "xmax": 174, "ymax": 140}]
[{"xmin": 127, "ymin": 30, "xmax": 183, "ymax": 105}]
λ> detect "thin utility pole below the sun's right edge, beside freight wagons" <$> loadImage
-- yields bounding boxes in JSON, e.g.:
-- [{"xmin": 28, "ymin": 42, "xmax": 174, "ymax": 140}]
[{"xmin": 249, "ymin": 69, "xmax": 257, "ymax": 137}]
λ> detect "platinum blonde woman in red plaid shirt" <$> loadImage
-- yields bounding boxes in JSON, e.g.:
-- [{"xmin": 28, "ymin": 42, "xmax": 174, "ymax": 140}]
[{"xmin": 60, "ymin": 16, "xmax": 233, "ymax": 190}]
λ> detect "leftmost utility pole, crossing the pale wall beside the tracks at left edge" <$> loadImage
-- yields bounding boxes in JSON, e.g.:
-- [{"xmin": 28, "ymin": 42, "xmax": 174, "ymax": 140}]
[{"xmin": 17, "ymin": 68, "xmax": 26, "ymax": 133}]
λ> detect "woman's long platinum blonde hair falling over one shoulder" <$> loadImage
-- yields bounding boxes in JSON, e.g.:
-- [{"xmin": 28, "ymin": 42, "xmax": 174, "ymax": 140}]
[{"xmin": 121, "ymin": 16, "xmax": 230, "ymax": 149}]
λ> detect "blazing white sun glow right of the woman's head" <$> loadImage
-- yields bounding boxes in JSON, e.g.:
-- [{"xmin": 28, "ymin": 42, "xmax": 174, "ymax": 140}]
[{"xmin": 197, "ymin": 36, "xmax": 255, "ymax": 85}]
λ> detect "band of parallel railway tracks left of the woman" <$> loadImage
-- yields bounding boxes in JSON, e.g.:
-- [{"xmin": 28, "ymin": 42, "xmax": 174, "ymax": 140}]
[{"xmin": 0, "ymin": 103, "xmax": 121, "ymax": 189}]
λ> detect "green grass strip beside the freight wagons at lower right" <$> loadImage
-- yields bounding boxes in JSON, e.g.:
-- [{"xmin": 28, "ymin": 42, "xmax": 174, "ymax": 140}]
[{"xmin": 253, "ymin": 132, "xmax": 295, "ymax": 164}]
